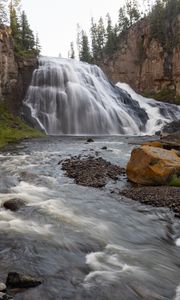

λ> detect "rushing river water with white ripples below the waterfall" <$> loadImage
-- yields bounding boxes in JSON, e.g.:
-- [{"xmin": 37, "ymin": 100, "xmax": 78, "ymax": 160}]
[{"xmin": 0, "ymin": 136, "xmax": 180, "ymax": 300}]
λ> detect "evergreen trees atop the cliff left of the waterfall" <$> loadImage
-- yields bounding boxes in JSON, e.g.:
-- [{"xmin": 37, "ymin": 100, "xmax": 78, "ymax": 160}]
[{"xmin": 0, "ymin": 0, "xmax": 41, "ymax": 56}]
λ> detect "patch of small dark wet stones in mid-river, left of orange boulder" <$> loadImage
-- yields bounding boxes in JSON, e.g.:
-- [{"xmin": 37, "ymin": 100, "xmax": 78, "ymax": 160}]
[{"xmin": 62, "ymin": 157, "xmax": 124, "ymax": 188}]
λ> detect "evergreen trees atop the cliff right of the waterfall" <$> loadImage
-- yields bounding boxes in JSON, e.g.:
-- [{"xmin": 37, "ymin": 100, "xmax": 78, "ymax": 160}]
[{"xmin": 69, "ymin": 0, "xmax": 180, "ymax": 63}]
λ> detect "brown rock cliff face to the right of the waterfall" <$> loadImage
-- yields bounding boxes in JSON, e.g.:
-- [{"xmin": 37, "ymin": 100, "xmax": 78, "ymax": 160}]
[{"xmin": 99, "ymin": 15, "xmax": 180, "ymax": 101}]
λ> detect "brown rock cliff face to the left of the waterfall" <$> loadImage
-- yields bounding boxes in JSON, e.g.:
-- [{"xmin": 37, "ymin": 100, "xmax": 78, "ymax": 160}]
[{"xmin": 0, "ymin": 27, "xmax": 37, "ymax": 113}]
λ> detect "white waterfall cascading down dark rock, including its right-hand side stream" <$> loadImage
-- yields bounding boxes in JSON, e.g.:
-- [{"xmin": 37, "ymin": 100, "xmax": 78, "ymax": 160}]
[{"xmin": 24, "ymin": 57, "xmax": 180, "ymax": 135}]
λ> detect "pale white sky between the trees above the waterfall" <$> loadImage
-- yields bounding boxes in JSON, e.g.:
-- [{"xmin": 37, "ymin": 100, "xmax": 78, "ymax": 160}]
[{"xmin": 22, "ymin": 0, "xmax": 150, "ymax": 57}]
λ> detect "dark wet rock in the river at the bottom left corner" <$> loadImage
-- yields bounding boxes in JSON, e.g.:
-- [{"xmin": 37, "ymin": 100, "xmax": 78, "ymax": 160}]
[{"xmin": 6, "ymin": 272, "xmax": 42, "ymax": 288}]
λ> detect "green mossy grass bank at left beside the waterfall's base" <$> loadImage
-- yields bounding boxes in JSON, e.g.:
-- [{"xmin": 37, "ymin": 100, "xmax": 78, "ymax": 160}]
[{"xmin": 0, "ymin": 101, "xmax": 44, "ymax": 147}]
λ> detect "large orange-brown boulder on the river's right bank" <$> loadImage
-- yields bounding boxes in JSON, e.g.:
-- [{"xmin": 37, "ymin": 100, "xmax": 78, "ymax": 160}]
[{"xmin": 126, "ymin": 145, "xmax": 180, "ymax": 185}]
